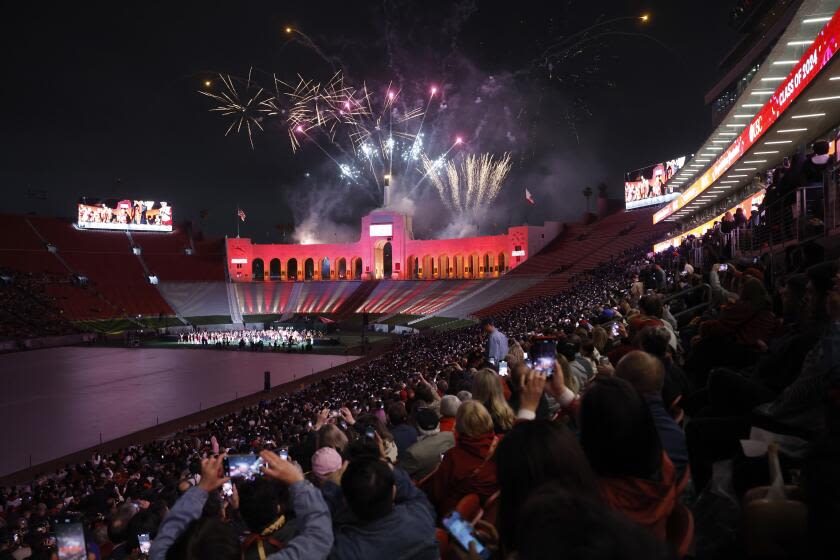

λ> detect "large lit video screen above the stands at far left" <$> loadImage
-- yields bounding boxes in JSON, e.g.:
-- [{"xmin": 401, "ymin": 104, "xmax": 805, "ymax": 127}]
[{"xmin": 76, "ymin": 199, "xmax": 172, "ymax": 231}]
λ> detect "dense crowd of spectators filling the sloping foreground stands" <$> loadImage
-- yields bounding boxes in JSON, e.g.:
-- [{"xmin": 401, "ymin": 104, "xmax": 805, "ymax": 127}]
[{"xmin": 0, "ymin": 237, "xmax": 840, "ymax": 560}]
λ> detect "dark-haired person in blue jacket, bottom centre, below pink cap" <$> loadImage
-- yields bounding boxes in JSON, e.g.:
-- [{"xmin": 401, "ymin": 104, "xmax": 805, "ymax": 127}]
[{"xmin": 330, "ymin": 458, "xmax": 439, "ymax": 560}]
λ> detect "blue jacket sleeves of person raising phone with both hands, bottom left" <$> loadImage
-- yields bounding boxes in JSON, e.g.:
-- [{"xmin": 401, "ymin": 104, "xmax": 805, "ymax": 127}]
[{"xmin": 149, "ymin": 480, "xmax": 333, "ymax": 560}]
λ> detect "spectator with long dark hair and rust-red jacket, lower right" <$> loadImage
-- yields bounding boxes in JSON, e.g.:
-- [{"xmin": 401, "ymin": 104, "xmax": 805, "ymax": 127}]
[{"xmin": 580, "ymin": 377, "xmax": 676, "ymax": 541}]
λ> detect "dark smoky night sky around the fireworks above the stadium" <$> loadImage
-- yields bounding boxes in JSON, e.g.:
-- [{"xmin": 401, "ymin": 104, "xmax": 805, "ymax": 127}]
[{"xmin": 0, "ymin": 0, "xmax": 736, "ymax": 241}]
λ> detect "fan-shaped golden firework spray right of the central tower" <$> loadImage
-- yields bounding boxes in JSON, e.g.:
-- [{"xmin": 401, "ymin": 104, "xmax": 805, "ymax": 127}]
[{"xmin": 422, "ymin": 153, "xmax": 511, "ymax": 214}]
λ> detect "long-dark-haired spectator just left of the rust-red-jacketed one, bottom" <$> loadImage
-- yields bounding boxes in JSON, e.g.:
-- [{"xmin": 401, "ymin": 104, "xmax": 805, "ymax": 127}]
[{"xmin": 496, "ymin": 420, "xmax": 600, "ymax": 553}]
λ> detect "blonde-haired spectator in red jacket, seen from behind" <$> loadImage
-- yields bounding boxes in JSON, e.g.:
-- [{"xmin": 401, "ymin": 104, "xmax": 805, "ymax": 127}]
[{"xmin": 428, "ymin": 401, "xmax": 499, "ymax": 516}]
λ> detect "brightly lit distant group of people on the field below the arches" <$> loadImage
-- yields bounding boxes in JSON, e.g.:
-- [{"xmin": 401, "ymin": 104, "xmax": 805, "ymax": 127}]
[{"xmin": 178, "ymin": 327, "xmax": 320, "ymax": 350}]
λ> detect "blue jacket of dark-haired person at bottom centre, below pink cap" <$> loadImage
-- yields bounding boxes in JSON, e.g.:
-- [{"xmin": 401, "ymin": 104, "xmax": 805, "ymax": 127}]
[{"xmin": 330, "ymin": 468, "xmax": 440, "ymax": 560}]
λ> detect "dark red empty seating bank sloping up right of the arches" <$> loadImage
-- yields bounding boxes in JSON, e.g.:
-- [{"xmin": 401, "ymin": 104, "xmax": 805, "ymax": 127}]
[{"xmin": 475, "ymin": 209, "xmax": 668, "ymax": 317}]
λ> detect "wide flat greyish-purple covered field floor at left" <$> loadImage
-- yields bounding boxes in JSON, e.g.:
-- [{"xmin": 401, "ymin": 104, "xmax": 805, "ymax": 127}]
[{"xmin": 0, "ymin": 347, "xmax": 358, "ymax": 476}]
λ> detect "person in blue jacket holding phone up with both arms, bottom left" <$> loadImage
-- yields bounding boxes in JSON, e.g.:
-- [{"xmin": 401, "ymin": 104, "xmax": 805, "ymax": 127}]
[{"xmin": 149, "ymin": 451, "xmax": 333, "ymax": 560}]
